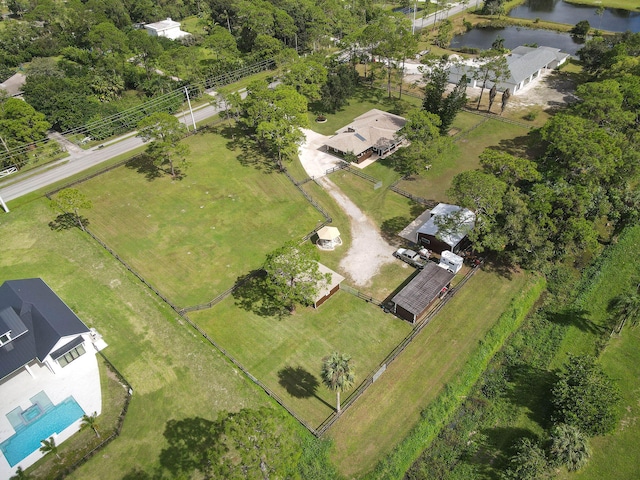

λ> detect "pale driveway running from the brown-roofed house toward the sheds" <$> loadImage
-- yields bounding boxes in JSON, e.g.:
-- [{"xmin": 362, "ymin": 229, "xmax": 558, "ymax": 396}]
[{"xmin": 299, "ymin": 130, "xmax": 397, "ymax": 287}]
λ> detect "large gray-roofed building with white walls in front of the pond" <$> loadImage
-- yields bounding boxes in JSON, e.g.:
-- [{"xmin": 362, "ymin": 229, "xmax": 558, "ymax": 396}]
[{"xmin": 449, "ymin": 46, "xmax": 570, "ymax": 95}]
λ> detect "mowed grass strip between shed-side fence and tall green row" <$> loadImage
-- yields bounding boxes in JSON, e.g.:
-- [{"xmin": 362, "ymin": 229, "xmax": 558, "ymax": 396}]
[{"xmin": 329, "ymin": 271, "xmax": 527, "ymax": 478}]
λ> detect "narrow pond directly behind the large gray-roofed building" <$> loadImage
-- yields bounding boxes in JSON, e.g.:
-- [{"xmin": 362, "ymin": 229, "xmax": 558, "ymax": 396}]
[{"xmin": 451, "ymin": 27, "xmax": 584, "ymax": 55}]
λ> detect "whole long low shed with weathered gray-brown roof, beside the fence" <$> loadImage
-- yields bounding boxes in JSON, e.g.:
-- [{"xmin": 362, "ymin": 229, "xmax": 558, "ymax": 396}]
[{"xmin": 390, "ymin": 262, "xmax": 454, "ymax": 323}]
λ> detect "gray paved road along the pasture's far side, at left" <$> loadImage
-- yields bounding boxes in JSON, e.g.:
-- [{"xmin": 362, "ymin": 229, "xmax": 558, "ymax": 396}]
[{"xmin": 0, "ymin": 102, "xmax": 220, "ymax": 203}]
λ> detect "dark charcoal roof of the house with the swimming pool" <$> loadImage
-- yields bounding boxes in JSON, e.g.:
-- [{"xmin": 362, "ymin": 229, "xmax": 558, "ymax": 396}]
[{"xmin": 0, "ymin": 278, "xmax": 89, "ymax": 379}]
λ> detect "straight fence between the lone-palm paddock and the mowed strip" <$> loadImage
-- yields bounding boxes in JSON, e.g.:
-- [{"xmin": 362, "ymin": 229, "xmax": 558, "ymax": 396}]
[{"xmin": 317, "ymin": 268, "xmax": 479, "ymax": 436}]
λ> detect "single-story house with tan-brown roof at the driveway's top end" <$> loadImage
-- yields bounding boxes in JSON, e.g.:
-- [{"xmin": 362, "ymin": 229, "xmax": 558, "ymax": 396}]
[{"xmin": 325, "ymin": 108, "xmax": 407, "ymax": 163}]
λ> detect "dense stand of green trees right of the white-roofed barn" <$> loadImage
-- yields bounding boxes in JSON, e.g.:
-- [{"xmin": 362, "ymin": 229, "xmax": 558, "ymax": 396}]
[{"xmin": 448, "ymin": 34, "xmax": 640, "ymax": 274}]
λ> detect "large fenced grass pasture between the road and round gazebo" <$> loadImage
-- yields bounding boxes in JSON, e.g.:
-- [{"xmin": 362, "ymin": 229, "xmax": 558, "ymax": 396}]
[{"xmin": 78, "ymin": 129, "xmax": 324, "ymax": 307}]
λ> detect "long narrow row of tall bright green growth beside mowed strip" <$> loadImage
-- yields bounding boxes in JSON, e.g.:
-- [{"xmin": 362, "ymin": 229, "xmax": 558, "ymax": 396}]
[{"xmin": 365, "ymin": 277, "xmax": 546, "ymax": 480}]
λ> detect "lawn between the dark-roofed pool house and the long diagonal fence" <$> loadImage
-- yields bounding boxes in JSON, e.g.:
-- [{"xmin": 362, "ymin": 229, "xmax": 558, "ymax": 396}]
[{"xmin": 0, "ymin": 199, "xmax": 266, "ymax": 479}]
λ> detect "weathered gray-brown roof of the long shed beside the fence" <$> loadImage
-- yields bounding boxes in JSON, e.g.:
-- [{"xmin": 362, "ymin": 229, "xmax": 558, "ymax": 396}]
[{"xmin": 391, "ymin": 262, "xmax": 454, "ymax": 316}]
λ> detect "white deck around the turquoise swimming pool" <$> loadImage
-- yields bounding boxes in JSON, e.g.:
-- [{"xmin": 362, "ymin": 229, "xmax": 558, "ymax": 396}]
[{"xmin": 0, "ymin": 345, "xmax": 102, "ymax": 479}]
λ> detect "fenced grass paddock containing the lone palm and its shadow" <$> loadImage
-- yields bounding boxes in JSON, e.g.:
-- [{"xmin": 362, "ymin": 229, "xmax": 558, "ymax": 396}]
[{"xmin": 189, "ymin": 292, "xmax": 411, "ymax": 426}]
